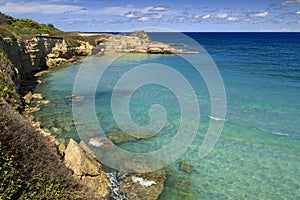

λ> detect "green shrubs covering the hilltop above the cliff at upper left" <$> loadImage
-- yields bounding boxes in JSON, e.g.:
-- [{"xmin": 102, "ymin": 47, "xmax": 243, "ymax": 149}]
[{"xmin": 0, "ymin": 12, "xmax": 63, "ymax": 37}]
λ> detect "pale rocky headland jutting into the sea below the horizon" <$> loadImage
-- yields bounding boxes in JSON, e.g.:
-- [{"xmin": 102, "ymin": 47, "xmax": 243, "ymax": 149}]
[{"xmin": 101, "ymin": 31, "xmax": 196, "ymax": 54}]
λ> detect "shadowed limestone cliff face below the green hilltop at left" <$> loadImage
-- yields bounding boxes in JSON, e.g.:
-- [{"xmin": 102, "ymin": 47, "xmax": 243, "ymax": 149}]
[{"xmin": 0, "ymin": 36, "xmax": 93, "ymax": 82}]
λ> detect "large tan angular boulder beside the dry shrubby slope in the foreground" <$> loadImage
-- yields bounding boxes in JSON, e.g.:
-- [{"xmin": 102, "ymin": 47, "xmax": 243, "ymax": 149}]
[{"xmin": 64, "ymin": 139, "xmax": 110, "ymax": 198}]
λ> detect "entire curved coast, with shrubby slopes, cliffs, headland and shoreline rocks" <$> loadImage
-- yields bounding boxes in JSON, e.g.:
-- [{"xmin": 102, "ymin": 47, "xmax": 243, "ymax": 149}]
[{"xmin": 0, "ymin": 13, "xmax": 195, "ymax": 200}]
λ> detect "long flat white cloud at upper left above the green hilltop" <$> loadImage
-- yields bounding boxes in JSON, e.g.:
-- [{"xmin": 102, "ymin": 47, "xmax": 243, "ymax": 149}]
[{"xmin": 0, "ymin": 1, "xmax": 86, "ymax": 14}]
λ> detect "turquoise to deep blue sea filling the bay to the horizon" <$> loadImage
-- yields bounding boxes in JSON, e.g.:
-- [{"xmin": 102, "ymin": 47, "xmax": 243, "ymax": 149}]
[{"xmin": 32, "ymin": 32, "xmax": 300, "ymax": 200}]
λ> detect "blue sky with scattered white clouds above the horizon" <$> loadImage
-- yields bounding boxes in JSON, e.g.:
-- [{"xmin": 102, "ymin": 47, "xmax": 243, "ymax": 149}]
[{"xmin": 0, "ymin": 0, "xmax": 300, "ymax": 32}]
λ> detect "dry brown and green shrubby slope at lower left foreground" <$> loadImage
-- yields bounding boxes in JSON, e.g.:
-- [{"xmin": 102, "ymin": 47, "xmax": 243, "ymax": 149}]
[{"xmin": 0, "ymin": 47, "xmax": 99, "ymax": 199}]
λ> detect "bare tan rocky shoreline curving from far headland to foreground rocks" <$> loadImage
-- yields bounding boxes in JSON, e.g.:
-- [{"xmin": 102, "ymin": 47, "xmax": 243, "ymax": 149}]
[{"xmin": 0, "ymin": 31, "xmax": 195, "ymax": 200}]
